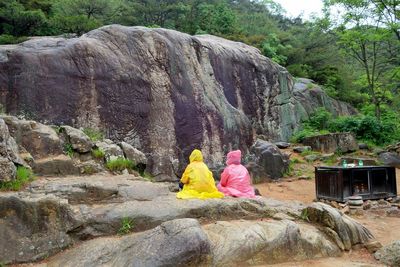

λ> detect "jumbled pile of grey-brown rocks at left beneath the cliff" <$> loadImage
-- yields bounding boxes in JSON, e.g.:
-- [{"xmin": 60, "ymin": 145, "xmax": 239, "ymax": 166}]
[{"xmin": 0, "ymin": 115, "xmax": 147, "ymax": 181}]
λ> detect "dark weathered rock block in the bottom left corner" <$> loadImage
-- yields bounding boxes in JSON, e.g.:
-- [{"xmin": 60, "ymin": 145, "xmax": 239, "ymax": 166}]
[{"xmin": 0, "ymin": 193, "xmax": 79, "ymax": 264}]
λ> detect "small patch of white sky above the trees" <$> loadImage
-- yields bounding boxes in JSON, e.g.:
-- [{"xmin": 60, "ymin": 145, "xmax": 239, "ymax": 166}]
[{"xmin": 274, "ymin": 0, "xmax": 323, "ymax": 19}]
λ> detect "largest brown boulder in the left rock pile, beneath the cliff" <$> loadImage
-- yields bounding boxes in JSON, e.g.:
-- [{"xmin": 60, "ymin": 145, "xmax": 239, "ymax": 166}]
[{"xmin": 2, "ymin": 116, "xmax": 63, "ymax": 160}]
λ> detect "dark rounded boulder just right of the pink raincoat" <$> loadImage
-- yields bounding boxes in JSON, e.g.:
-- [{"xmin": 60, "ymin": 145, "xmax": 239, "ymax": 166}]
[{"xmin": 246, "ymin": 140, "xmax": 289, "ymax": 182}]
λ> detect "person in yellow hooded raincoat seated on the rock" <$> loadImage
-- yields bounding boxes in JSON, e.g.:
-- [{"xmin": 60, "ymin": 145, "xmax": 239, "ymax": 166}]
[{"xmin": 176, "ymin": 149, "xmax": 224, "ymax": 199}]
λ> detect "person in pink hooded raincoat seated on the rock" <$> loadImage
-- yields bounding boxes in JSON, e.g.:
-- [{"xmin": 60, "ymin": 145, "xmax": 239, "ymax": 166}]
[{"xmin": 217, "ymin": 150, "xmax": 255, "ymax": 198}]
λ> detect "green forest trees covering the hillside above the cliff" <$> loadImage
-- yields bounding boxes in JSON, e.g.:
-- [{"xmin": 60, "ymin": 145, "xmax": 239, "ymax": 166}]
[{"xmin": 0, "ymin": 0, "xmax": 400, "ymax": 146}]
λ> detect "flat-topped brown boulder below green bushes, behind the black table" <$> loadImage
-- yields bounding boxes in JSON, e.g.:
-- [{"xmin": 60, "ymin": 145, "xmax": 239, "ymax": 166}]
[{"xmin": 303, "ymin": 133, "xmax": 358, "ymax": 153}]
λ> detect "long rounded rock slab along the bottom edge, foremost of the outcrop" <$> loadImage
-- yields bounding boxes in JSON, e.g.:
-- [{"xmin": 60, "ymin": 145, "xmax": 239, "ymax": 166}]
[{"xmin": 47, "ymin": 219, "xmax": 341, "ymax": 267}]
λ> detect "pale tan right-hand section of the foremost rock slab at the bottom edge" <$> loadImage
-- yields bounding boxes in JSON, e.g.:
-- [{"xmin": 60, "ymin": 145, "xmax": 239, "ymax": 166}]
[{"xmin": 204, "ymin": 220, "xmax": 341, "ymax": 266}]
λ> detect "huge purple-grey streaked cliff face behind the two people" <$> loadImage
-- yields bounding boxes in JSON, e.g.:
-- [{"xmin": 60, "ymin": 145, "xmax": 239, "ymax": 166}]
[{"xmin": 0, "ymin": 25, "xmax": 354, "ymax": 181}]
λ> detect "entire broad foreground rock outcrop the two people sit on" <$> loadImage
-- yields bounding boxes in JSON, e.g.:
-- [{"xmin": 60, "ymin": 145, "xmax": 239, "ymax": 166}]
[{"xmin": 0, "ymin": 175, "xmax": 373, "ymax": 266}]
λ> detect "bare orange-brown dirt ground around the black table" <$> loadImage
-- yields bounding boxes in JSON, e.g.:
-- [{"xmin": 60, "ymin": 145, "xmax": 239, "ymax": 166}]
[{"xmin": 255, "ymin": 169, "xmax": 400, "ymax": 267}]
